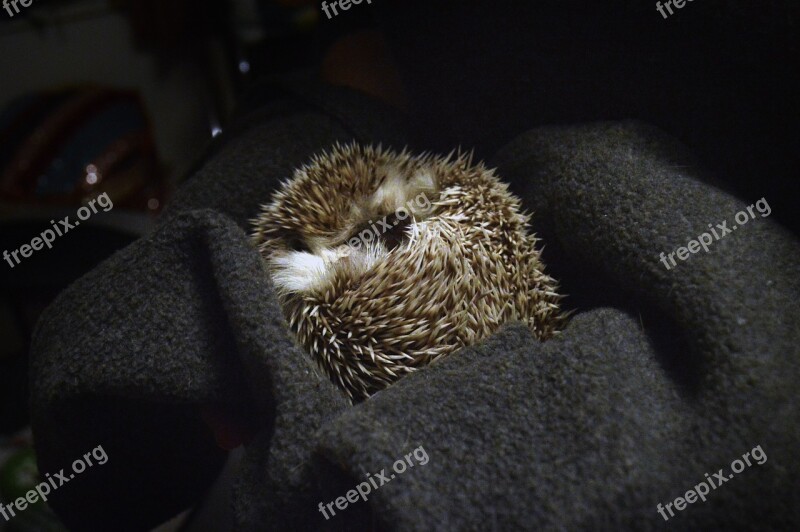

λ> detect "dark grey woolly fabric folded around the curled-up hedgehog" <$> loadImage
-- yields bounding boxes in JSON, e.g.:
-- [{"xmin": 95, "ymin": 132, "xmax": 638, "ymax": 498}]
[{"xmin": 32, "ymin": 87, "xmax": 800, "ymax": 531}]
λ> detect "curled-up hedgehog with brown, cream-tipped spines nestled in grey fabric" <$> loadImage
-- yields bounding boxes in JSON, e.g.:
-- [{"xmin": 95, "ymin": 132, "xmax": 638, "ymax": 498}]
[{"xmin": 252, "ymin": 144, "xmax": 564, "ymax": 400}]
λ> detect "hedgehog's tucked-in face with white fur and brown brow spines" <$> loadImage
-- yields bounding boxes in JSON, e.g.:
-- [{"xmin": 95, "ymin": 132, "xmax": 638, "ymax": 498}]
[{"xmin": 265, "ymin": 163, "xmax": 436, "ymax": 296}]
